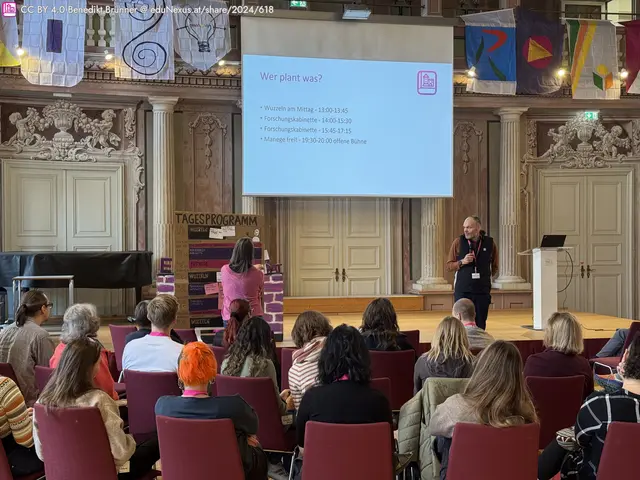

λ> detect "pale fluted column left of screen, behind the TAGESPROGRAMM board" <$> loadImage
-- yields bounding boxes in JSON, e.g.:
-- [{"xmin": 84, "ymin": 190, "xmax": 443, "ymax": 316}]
[{"xmin": 149, "ymin": 97, "xmax": 178, "ymax": 272}]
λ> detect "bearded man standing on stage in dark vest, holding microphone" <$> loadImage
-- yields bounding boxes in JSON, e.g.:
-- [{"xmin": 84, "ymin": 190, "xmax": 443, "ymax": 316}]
[{"xmin": 447, "ymin": 216, "xmax": 498, "ymax": 329}]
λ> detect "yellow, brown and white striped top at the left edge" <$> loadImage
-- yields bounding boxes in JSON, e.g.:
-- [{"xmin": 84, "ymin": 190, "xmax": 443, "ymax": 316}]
[{"xmin": 0, "ymin": 377, "xmax": 33, "ymax": 448}]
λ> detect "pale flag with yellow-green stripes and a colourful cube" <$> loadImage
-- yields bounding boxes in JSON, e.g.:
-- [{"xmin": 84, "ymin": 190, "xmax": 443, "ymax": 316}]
[{"xmin": 566, "ymin": 19, "xmax": 620, "ymax": 100}]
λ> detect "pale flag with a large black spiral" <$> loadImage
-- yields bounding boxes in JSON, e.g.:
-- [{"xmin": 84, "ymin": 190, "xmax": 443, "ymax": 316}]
[{"xmin": 114, "ymin": 0, "xmax": 175, "ymax": 80}]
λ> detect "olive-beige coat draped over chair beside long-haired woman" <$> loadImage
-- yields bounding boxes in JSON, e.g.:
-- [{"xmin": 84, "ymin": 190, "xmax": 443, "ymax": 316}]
[{"xmin": 398, "ymin": 377, "xmax": 469, "ymax": 480}]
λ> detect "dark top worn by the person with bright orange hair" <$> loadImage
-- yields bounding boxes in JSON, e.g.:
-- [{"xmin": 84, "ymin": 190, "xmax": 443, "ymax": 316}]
[{"xmin": 156, "ymin": 395, "xmax": 258, "ymax": 473}]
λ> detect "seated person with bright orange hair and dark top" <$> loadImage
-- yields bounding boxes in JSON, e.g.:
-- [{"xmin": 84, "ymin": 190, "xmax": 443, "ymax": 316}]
[{"xmin": 156, "ymin": 342, "xmax": 268, "ymax": 480}]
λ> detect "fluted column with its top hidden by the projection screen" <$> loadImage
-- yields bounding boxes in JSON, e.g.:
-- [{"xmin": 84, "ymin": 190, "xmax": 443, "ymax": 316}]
[{"xmin": 413, "ymin": 198, "xmax": 452, "ymax": 291}]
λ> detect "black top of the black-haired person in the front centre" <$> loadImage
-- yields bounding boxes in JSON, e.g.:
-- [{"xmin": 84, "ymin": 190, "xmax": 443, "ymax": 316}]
[{"xmin": 296, "ymin": 380, "xmax": 393, "ymax": 447}]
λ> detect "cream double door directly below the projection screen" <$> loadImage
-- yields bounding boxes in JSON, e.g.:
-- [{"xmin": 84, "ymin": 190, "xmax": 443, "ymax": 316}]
[{"xmin": 288, "ymin": 198, "xmax": 391, "ymax": 297}]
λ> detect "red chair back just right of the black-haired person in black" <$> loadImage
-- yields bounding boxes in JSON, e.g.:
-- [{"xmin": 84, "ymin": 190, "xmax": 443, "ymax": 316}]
[{"xmin": 369, "ymin": 350, "xmax": 416, "ymax": 410}]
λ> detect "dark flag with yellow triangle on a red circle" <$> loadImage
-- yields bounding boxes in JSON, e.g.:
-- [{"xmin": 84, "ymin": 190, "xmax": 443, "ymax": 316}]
[{"xmin": 516, "ymin": 7, "xmax": 564, "ymax": 95}]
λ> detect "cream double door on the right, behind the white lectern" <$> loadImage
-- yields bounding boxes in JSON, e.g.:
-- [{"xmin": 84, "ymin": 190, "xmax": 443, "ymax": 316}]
[{"xmin": 538, "ymin": 168, "xmax": 633, "ymax": 318}]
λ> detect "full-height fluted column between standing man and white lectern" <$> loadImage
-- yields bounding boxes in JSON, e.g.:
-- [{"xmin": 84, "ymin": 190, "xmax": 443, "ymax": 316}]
[{"xmin": 493, "ymin": 107, "xmax": 531, "ymax": 290}]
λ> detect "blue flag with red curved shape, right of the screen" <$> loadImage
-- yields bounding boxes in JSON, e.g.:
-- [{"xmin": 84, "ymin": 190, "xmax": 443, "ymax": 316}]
[{"xmin": 462, "ymin": 8, "xmax": 516, "ymax": 95}]
